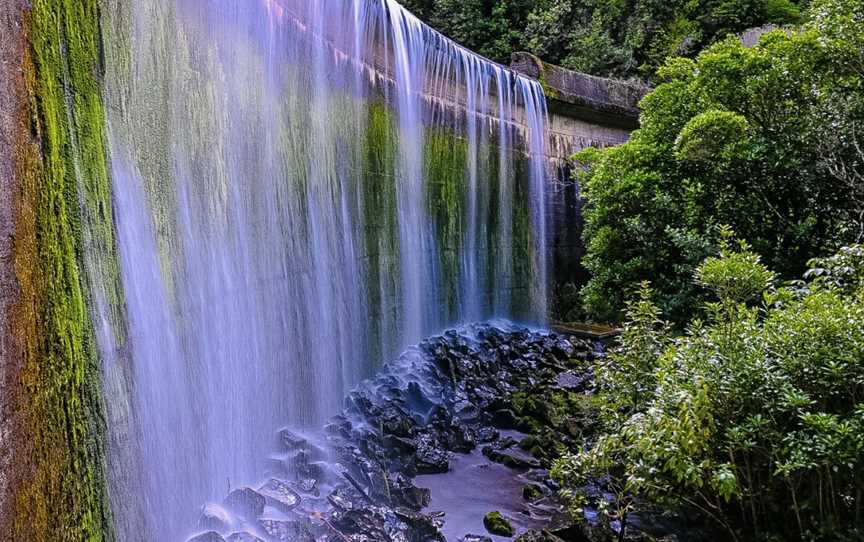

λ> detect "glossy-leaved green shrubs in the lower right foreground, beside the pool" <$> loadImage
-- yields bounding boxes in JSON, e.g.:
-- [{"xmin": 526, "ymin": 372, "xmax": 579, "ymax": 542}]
[{"xmin": 553, "ymin": 238, "xmax": 864, "ymax": 540}]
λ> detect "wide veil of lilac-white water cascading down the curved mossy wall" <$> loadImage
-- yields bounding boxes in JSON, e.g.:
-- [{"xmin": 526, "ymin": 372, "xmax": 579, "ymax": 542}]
[{"xmin": 101, "ymin": 0, "xmax": 547, "ymax": 540}]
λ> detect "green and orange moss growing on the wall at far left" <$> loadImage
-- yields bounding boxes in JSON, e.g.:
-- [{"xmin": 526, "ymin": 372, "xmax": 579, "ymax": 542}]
[{"xmin": 13, "ymin": 0, "xmax": 122, "ymax": 541}]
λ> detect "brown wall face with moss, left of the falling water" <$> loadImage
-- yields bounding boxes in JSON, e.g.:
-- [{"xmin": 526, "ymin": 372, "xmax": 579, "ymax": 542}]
[{"xmin": 0, "ymin": 0, "xmax": 119, "ymax": 541}]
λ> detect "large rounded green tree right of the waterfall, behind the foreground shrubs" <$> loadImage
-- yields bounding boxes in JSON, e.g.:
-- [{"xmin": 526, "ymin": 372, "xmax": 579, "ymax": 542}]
[{"xmin": 577, "ymin": 0, "xmax": 864, "ymax": 323}]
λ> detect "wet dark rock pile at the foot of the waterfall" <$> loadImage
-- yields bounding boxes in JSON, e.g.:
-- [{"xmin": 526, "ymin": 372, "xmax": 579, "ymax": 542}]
[{"xmin": 189, "ymin": 324, "xmax": 596, "ymax": 542}]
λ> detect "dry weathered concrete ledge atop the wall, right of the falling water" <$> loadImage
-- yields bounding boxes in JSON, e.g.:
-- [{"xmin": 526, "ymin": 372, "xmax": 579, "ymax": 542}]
[{"xmin": 510, "ymin": 53, "xmax": 650, "ymax": 129}]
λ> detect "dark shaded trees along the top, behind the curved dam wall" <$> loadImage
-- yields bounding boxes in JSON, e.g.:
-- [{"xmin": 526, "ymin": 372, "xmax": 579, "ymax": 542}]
[{"xmin": 402, "ymin": 0, "xmax": 807, "ymax": 77}]
